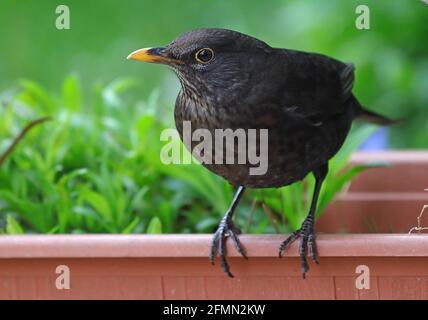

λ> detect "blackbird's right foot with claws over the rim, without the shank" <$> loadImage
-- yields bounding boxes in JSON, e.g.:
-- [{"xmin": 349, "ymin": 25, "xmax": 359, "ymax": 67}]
[{"xmin": 279, "ymin": 218, "xmax": 318, "ymax": 279}]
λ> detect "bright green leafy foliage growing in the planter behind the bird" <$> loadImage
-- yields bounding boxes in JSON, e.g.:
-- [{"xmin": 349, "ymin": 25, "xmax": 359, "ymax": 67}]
[{"xmin": 0, "ymin": 76, "xmax": 382, "ymax": 234}]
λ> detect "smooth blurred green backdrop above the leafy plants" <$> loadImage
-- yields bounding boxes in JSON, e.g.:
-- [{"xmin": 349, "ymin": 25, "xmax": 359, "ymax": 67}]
[{"xmin": 0, "ymin": 0, "xmax": 428, "ymax": 148}]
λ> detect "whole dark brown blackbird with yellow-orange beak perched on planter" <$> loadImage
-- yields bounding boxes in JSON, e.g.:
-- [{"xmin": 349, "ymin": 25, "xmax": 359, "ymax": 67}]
[{"xmin": 128, "ymin": 28, "xmax": 395, "ymax": 277}]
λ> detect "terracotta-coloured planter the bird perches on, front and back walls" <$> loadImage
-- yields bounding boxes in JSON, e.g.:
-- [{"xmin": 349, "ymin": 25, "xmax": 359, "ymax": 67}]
[{"xmin": 0, "ymin": 153, "xmax": 428, "ymax": 299}]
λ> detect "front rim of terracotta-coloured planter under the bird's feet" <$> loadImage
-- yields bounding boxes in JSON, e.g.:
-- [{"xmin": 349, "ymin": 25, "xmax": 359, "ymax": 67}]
[{"xmin": 0, "ymin": 234, "xmax": 428, "ymax": 259}]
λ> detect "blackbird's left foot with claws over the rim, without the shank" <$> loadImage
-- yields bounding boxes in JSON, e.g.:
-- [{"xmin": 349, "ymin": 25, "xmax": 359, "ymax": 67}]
[{"xmin": 209, "ymin": 215, "xmax": 247, "ymax": 278}]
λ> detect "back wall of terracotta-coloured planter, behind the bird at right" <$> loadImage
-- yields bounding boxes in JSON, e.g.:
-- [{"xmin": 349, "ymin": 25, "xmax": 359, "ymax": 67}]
[{"xmin": 317, "ymin": 151, "xmax": 428, "ymax": 232}]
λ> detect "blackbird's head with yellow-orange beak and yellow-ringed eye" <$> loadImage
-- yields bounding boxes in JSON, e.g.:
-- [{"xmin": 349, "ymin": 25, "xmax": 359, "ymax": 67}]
[{"xmin": 128, "ymin": 29, "xmax": 272, "ymax": 100}]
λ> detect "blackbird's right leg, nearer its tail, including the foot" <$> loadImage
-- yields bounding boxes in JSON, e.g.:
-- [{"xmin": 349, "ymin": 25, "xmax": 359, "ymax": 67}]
[{"xmin": 279, "ymin": 165, "xmax": 328, "ymax": 278}]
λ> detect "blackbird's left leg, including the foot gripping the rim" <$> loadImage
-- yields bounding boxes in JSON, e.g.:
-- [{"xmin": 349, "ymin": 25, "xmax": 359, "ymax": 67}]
[{"xmin": 209, "ymin": 186, "xmax": 247, "ymax": 278}]
